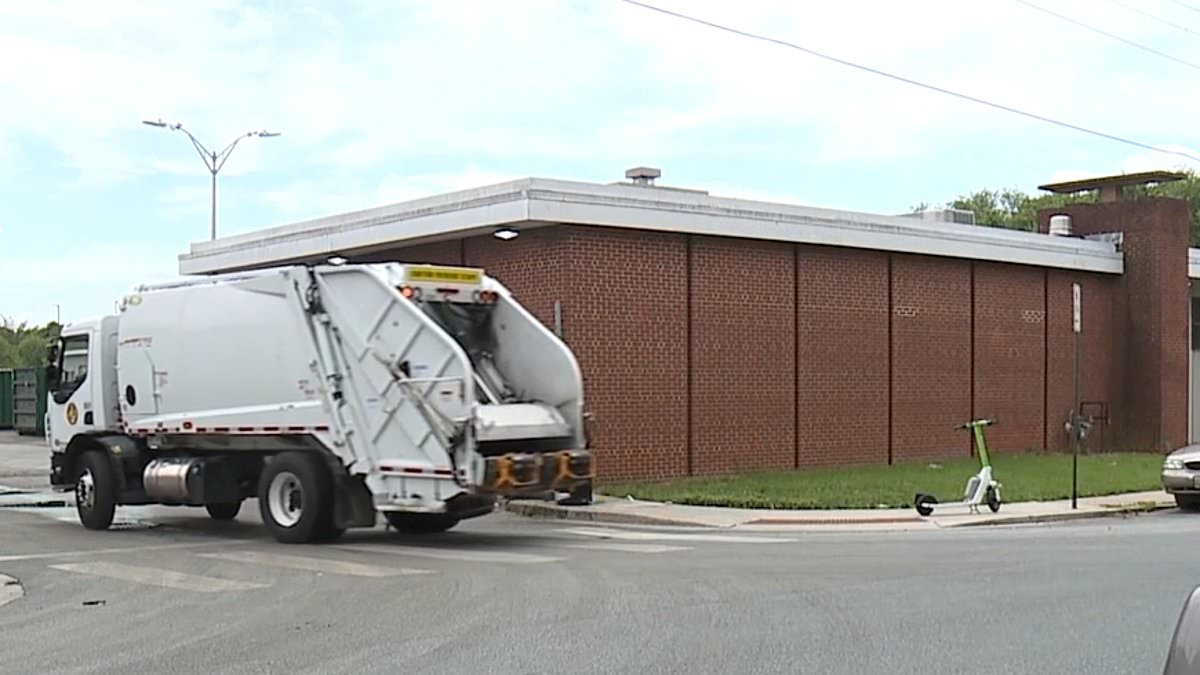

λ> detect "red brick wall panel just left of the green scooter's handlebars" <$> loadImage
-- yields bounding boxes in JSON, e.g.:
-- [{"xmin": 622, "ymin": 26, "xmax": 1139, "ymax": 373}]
[{"xmin": 892, "ymin": 255, "xmax": 971, "ymax": 461}]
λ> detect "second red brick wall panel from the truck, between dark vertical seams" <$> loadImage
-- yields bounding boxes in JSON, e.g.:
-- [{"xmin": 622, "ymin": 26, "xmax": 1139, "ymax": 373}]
[{"xmin": 689, "ymin": 237, "xmax": 796, "ymax": 474}]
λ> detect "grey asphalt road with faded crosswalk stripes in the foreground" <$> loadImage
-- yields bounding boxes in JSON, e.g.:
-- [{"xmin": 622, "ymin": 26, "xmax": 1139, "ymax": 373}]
[{"xmin": 0, "ymin": 502, "xmax": 1200, "ymax": 675}]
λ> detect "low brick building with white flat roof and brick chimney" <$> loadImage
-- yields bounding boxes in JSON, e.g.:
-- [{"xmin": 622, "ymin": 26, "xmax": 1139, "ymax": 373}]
[{"xmin": 180, "ymin": 172, "xmax": 1200, "ymax": 479}]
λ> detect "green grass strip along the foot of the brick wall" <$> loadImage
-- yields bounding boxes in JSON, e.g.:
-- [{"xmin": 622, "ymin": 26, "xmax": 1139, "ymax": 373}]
[{"xmin": 599, "ymin": 453, "xmax": 1163, "ymax": 509}]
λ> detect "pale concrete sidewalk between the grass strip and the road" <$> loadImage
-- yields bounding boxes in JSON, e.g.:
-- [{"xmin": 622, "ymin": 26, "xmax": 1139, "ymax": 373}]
[{"xmin": 505, "ymin": 490, "xmax": 1175, "ymax": 532}]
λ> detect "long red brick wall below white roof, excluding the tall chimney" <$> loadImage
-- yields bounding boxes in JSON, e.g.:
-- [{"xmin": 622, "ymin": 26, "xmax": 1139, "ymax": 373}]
[{"xmin": 369, "ymin": 214, "xmax": 1166, "ymax": 482}]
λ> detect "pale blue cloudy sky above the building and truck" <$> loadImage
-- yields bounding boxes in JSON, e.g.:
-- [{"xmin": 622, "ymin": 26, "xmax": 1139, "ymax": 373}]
[{"xmin": 0, "ymin": 0, "xmax": 1200, "ymax": 323}]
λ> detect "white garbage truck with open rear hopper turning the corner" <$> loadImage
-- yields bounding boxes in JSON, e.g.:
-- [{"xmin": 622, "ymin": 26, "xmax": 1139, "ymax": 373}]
[{"xmin": 47, "ymin": 263, "xmax": 594, "ymax": 543}]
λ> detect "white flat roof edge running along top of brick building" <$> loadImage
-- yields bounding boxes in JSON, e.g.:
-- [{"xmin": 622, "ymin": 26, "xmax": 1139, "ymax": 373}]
[{"xmin": 179, "ymin": 178, "xmax": 1124, "ymax": 275}]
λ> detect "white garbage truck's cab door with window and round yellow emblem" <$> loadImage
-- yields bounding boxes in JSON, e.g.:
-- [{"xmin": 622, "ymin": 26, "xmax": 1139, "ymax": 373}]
[{"xmin": 47, "ymin": 331, "xmax": 98, "ymax": 449}]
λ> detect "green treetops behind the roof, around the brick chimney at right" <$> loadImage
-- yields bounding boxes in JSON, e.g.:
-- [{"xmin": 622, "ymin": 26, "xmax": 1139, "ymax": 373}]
[{"xmin": 946, "ymin": 171, "xmax": 1200, "ymax": 246}]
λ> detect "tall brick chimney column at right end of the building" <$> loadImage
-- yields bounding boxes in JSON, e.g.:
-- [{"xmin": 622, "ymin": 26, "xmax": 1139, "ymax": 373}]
[{"xmin": 1038, "ymin": 198, "xmax": 1190, "ymax": 450}]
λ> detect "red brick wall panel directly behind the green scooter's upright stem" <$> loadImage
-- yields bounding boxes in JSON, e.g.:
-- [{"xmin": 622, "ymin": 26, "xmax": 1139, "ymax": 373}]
[{"xmin": 964, "ymin": 262, "xmax": 1046, "ymax": 452}]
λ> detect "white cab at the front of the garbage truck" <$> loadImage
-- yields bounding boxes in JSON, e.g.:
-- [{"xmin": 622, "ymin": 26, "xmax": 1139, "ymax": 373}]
[{"xmin": 46, "ymin": 316, "xmax": 120, "ymax": 485}]
